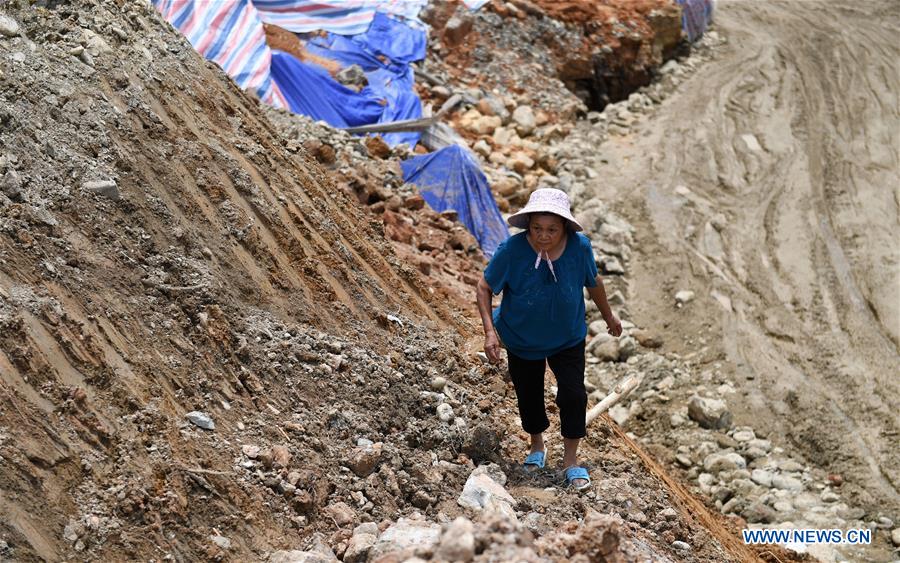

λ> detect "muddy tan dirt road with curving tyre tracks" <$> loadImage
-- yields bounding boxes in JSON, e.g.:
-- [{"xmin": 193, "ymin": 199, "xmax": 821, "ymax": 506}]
[{"xmin": 597, "ymin": 1, "xmax": 900, "ymax": 520}]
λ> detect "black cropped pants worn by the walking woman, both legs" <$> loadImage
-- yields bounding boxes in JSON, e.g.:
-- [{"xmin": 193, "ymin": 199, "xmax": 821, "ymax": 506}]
[{"xmin": 507, "ymin": 341, "xmax": 587, "ymax": 438}]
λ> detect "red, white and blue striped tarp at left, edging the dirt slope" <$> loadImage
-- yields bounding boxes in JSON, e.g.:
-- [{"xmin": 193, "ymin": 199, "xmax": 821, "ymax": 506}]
[{"xmin": 153, "ymin": 0, "xmax": 287, "ymax": 108}]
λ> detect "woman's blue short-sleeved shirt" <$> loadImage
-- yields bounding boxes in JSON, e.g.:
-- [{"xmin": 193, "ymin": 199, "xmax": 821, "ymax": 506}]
[{"xmin": 484, "ymin": 232, "xmax": 597, "ymax": 360}]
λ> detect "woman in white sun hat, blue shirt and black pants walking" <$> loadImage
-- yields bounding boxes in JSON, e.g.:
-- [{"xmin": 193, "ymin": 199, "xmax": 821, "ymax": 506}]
[{"xmin": 478, "ymin": 188, "xmax": 622, "ymax": 490}]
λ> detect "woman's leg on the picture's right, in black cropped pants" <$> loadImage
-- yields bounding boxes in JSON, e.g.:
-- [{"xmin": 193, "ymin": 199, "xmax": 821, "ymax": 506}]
[{"xmin": 547, "ymin": 341, "xmax": 587, "ymax": 476}]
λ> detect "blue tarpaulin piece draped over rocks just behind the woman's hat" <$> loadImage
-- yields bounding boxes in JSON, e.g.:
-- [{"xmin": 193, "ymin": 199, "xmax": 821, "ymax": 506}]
[{"xmin": 400, "ymin": 145, "xmax": 509, "ymax": 257}]
